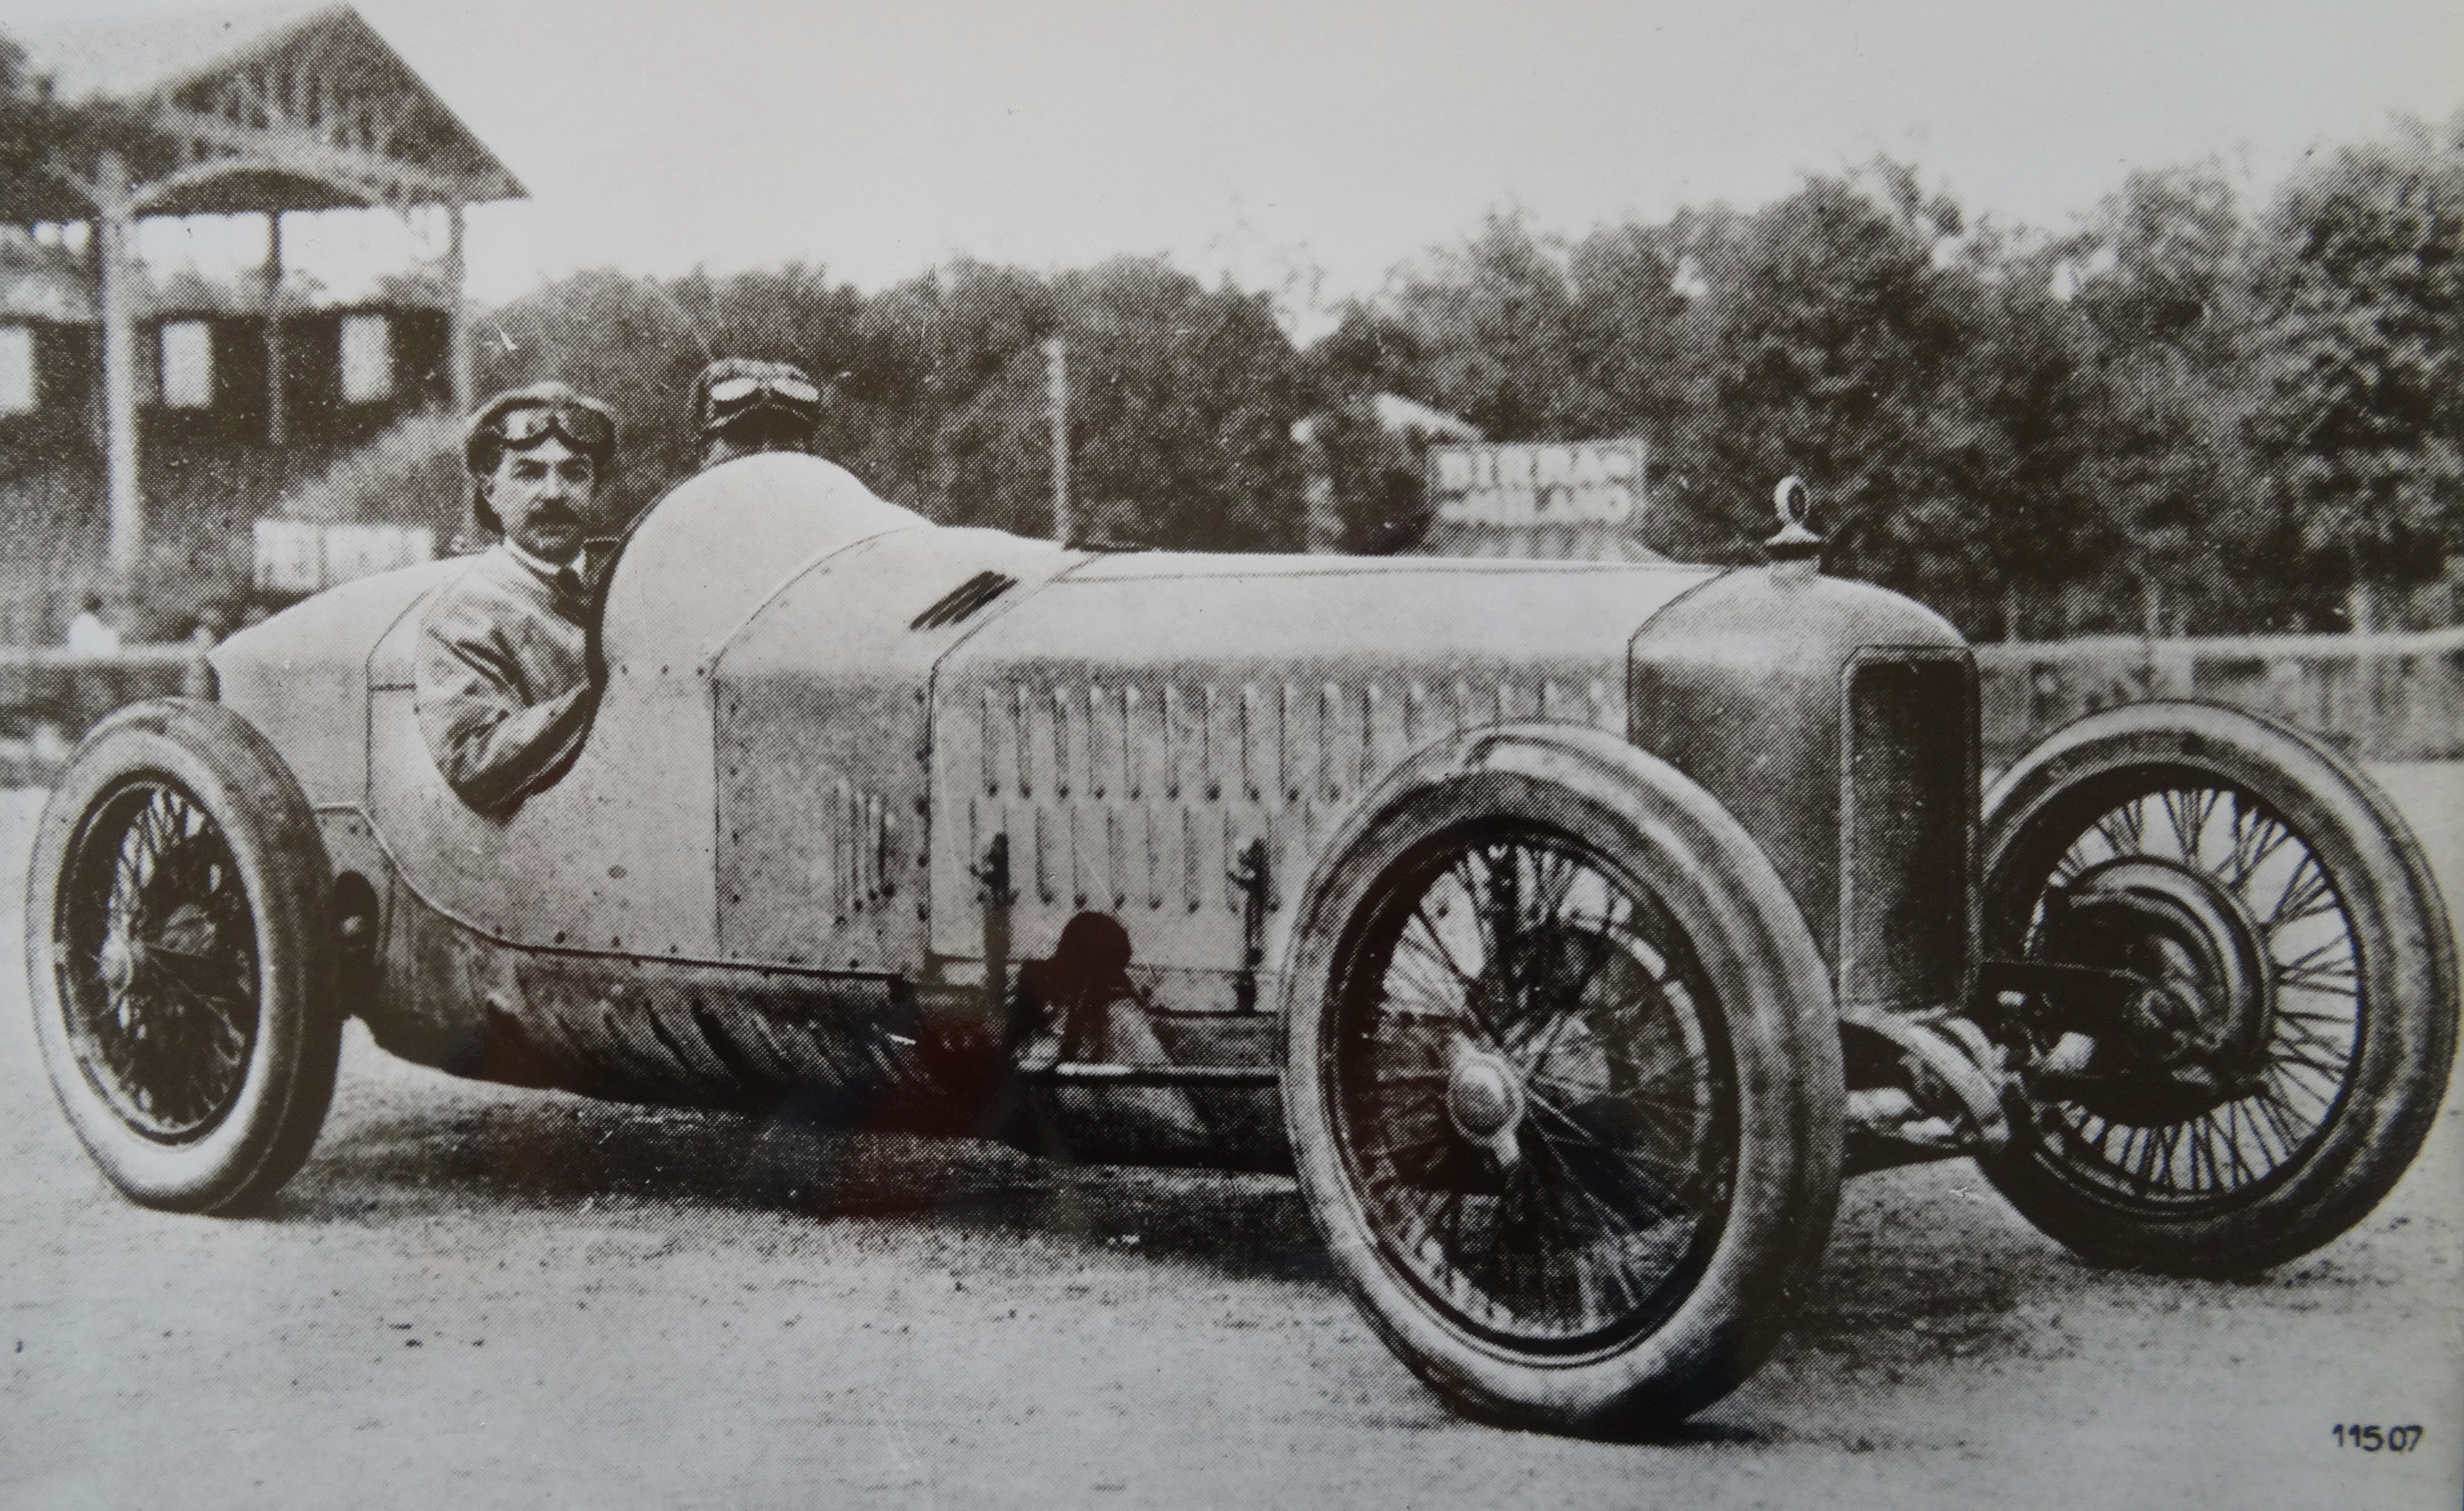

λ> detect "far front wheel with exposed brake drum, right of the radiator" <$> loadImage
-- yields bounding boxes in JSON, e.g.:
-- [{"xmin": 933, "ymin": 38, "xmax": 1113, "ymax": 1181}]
[{"xmin": 1983, "ymin": 705, "xmax": 2454, "ymax": 1274}]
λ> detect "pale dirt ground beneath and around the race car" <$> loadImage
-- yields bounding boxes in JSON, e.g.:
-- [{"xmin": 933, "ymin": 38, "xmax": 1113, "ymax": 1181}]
[{"xmin": 0, "ymin": 766, "xmax": 2464, "ymax": 1511}]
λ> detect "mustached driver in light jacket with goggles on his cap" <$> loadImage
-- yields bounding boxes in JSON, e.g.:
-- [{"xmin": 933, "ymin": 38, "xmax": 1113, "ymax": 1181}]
[{"xmin": 417, "ymin": 382, "xmax": 616, "ymax": 816}]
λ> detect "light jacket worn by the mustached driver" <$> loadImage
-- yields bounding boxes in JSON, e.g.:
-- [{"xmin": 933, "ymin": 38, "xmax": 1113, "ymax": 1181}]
[{"xmin": 419, "ymin": 545, "xmax": 597, "ymax": 813}]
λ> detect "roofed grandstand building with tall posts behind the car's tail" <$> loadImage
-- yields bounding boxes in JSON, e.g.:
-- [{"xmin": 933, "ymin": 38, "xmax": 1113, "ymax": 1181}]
[{"xmin": 0, "ymin": 5, "xmax": 522, "ymax": 644}]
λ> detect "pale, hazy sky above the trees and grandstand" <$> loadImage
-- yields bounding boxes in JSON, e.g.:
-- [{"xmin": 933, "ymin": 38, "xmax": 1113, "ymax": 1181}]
[{"xmin": 0, "ymin": 0, "xmax": 2464, "ymax": 328}]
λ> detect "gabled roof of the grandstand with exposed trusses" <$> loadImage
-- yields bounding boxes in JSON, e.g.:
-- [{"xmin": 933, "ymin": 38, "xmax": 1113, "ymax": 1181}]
[{"xmin": 5, "ymin": 3, "xmax": 525, "ymax": 222}]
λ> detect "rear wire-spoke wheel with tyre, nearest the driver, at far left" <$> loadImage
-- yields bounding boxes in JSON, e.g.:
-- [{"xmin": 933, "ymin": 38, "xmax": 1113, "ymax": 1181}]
[{"xmin": 27, "ymin": 700, "xmax": 340, "ymax": 1210}]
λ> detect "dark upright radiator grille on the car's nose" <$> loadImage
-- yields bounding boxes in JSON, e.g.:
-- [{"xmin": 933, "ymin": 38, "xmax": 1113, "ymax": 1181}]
[{"xmin": 1840, "ymin": 653, "xmax": 1976, "ymax": 1008}]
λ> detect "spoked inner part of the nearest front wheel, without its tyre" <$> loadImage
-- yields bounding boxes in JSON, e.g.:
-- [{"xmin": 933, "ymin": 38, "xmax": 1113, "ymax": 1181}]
[{"xmin": 1331, "ymin": 824, "xmax": 1737, "ymax": 1353}]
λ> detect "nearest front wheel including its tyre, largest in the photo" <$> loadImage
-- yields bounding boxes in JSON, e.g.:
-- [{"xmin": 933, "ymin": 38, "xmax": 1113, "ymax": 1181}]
[{"xmin": 1286, "ymin": 737, "xmax": 1840, "ymax": 1429}]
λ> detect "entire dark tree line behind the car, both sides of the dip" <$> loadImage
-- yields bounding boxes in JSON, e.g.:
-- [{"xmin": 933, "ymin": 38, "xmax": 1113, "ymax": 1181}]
[{"xmin": 481, "ymin": 113, "xmax": 2464, "ymax": 638}]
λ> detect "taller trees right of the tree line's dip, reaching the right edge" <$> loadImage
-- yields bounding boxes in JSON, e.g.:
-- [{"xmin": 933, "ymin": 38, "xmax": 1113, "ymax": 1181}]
[{"xmin": 1340, "ymin": 131, "xmax": 2464, "ymax": 634}]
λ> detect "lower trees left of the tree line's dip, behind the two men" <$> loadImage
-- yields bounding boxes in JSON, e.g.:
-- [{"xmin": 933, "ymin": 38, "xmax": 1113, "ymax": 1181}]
[{"xmin": 481, "ymin": 259, "xmax": 1311, "ymax": 550}]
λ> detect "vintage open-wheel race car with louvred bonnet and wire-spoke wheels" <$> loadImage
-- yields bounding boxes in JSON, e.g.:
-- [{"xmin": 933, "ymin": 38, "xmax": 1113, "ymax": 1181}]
[{"xmin": 27, "ymin": 456, "xmax": 2457, "ymax": 1432}]
